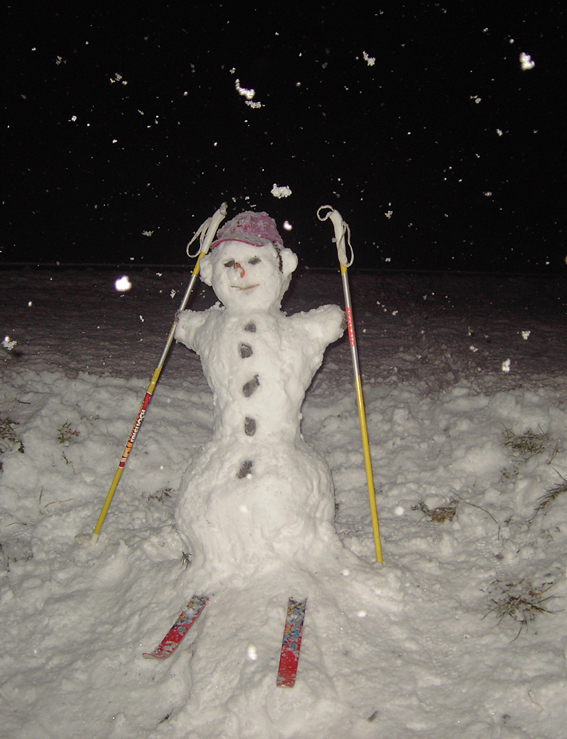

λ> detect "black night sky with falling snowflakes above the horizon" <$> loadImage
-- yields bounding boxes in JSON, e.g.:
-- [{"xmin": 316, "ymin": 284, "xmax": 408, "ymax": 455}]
[{"xmin": 0, "ymin": 0, "xmax": 567, "ymax": 273}]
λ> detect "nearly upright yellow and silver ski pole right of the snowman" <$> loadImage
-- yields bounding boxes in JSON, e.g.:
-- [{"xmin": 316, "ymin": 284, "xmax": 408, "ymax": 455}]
[{"xmin": 317, "ymin": 205, "xmax": 382, "ymax": 562}]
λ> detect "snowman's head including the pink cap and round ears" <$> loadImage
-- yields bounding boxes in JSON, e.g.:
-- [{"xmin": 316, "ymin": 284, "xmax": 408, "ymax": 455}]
[{"xmin": 200, "ymin": 212, "xmax": 297, "ymax": 313}]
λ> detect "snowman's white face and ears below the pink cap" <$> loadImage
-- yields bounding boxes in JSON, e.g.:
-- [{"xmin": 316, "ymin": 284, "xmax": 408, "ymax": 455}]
[{"xmin": 201, "ymin": 241, "xmax": 297, "ymax": 313}]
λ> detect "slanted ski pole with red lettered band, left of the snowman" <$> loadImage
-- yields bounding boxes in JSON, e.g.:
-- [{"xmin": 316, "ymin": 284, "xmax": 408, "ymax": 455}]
[{"xmin": 91, "ymin": 203, "xmax": 226, "ymax": 546}]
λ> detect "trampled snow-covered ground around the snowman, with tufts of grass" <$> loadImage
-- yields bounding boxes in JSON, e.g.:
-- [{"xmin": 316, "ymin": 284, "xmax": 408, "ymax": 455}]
[{"xmin": 0, "ymin": 269, "xmax": 567, "ymax": 739}]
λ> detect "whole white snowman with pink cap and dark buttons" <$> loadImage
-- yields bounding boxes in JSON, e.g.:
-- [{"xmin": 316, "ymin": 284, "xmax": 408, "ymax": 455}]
[{"xmin": 175, "ymin": 212, "xmax": 345, "ymax": 587}]
